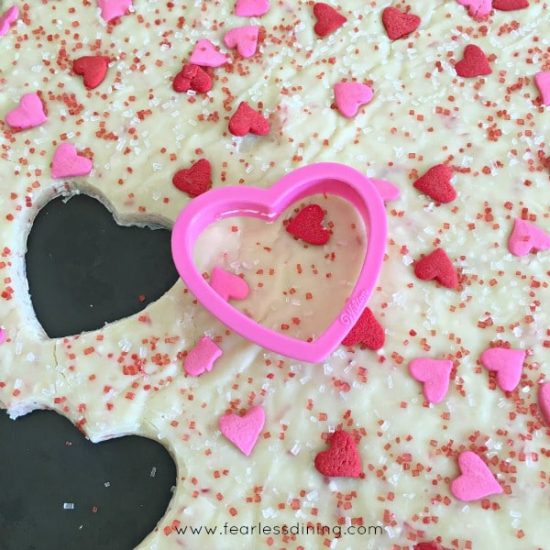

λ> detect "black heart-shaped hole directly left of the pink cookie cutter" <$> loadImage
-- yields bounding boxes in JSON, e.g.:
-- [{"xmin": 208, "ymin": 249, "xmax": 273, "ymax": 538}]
[{"xmin": 25, "ymin": 195, "xmax": 178, "ymax": 338}]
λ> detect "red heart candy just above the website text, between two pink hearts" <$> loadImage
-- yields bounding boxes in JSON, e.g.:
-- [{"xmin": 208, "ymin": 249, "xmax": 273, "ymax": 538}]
[{"xmin": 315, "ymin": 430, "xmax": 362, "ymax": 477}]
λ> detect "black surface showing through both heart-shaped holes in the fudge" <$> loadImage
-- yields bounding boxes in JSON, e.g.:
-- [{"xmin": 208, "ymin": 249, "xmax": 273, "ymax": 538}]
[{"xmin": 0, "ymin": 195, "xmax": 177, "ymax": 550}]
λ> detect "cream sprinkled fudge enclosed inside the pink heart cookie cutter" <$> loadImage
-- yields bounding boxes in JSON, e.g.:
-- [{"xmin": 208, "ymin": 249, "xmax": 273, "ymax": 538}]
[{"xmin": 193, "ymin": 194, "xmax": 366, "ymax": 342}]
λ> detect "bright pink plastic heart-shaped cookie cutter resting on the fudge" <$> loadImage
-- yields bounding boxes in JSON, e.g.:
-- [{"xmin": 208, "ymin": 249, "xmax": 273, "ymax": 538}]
[{"xmin": 172, "ymin": 163, "xmax": 387, "ymax": 363}]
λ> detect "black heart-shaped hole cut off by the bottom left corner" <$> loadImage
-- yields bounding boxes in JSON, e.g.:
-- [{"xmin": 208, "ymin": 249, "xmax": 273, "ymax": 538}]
[{"xmin": 0, "ymin": 411, "xmax": 176, "ymax": 550}]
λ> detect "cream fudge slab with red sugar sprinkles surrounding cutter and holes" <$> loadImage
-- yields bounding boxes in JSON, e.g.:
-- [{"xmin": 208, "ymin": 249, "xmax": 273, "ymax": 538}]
[{"xmin": 0, "ymin": 0, "xmax": 550, "ymax": 550}]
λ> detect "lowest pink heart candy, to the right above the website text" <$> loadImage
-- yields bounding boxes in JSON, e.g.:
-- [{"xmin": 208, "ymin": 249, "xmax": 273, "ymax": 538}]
[{"xmin": 451, "ymin": 451, "xmax": 502, "ymax": 502}]
